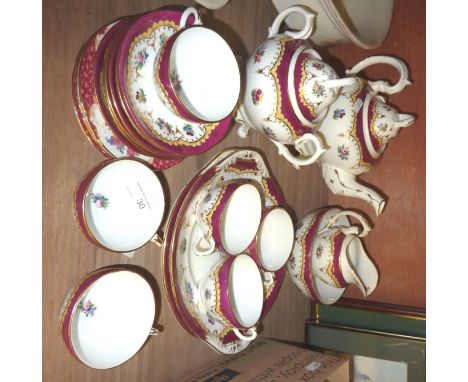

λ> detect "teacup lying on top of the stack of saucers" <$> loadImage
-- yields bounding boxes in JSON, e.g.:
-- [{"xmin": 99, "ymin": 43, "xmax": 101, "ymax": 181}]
[{"xmin": 154, "ymin": 10, "xmax": 240, "ymax": 123}]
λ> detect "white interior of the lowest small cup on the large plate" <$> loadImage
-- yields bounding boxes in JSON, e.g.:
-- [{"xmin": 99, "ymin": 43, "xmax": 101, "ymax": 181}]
[{"xmin": 228, "ymin": 254, "xmax": 263, "ymax": 328}]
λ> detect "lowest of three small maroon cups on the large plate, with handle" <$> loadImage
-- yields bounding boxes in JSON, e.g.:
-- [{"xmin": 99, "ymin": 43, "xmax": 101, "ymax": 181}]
[{"xmin": 199, "ymin": 254, "xmax": 263, "ymax": 341}]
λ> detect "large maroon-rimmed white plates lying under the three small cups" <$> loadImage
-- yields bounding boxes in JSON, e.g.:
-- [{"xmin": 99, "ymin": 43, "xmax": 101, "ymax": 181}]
[{"xmin": 163, "ymin": 150, "xmax": 284, "ymax": 354}]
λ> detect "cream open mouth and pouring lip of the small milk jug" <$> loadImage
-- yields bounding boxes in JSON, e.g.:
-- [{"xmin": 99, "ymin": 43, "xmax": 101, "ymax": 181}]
[{"xmin": 340, "ymin": 235, "xmax": 379, "ymax": 297}]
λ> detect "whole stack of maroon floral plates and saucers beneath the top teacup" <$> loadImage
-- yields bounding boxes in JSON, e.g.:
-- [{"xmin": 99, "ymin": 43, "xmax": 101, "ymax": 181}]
[{"xmin": 72, "ymin": 10, "xmax": 232, "ymax": 170}]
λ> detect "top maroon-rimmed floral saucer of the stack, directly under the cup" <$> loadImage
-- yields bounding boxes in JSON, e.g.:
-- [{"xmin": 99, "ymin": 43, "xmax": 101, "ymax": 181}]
[{"xmin": 116, "ymin": 10, "xmax": 232, "ymax": 156}]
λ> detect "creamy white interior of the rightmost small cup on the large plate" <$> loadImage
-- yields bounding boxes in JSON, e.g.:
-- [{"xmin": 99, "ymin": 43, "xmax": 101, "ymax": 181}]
[{"xmin": 257, "ymin": 208, "xmax": 294, "ymax": 272}]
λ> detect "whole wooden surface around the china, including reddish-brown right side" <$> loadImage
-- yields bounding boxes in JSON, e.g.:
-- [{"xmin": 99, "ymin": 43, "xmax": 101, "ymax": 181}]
[{"xmin": 43, "ymin": 0, "xmax": 425, "ymax": 382}]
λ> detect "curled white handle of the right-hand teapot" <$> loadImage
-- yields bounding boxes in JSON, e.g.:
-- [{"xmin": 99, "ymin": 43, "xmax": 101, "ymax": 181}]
[{"xmin": 346, "ymin": 56, "xmax": 411, "ymax": 94}]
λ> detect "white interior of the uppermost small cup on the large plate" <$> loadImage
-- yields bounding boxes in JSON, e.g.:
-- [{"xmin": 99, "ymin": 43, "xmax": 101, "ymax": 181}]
[{"xmin": 220, "ymin": 184, "xmax": 262, "ymax": 255}]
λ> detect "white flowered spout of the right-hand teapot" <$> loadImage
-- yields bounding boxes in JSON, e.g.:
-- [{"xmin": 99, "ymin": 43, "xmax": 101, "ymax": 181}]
[{"xmin": 321, "ymin": 163, "xmax": 385, "ymax": 215}]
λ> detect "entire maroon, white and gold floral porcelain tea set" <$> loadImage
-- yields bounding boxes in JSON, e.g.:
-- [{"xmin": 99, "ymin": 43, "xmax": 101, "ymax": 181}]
[{"xmin": 64, "ymin": 1, "xmax": 414, "ymax": 368}]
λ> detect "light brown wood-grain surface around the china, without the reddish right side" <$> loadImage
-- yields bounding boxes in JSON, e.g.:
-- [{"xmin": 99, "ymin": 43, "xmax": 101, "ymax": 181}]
[{"xmin": 43, "ymin": 0, "xmax": 327, "ymax": 382}]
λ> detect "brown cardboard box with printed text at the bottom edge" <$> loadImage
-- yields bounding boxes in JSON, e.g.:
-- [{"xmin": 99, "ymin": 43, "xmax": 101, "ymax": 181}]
[{"xmin": 181, "ymin": 338, "xmax": 349, "ymax": 382}]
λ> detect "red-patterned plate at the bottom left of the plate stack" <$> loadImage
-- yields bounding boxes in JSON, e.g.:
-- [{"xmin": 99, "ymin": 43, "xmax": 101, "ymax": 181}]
[{"xmin": 72, "ymin": 20, "xmax": 179, "ymax": 170}]
